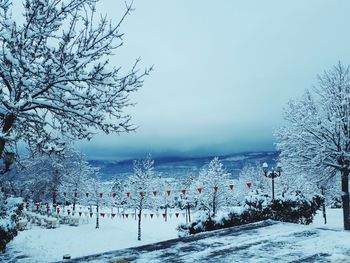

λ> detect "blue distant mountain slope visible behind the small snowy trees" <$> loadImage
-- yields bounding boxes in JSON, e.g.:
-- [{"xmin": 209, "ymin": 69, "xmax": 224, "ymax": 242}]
[{"xmin": 89, "ymin": 151, "xmax": 278, "ymax": 180}]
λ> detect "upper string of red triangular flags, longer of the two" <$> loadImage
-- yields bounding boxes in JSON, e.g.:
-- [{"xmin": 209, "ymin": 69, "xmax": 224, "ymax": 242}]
[{"xmin": 6, "ymin": 182, "xmax": 253, "ymax": 198}]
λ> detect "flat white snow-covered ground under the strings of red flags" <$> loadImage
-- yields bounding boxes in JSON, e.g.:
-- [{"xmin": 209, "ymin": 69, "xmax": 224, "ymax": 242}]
[{"xmin": 1, "ymin": 209, "xmax": 350, "ymax": 262}]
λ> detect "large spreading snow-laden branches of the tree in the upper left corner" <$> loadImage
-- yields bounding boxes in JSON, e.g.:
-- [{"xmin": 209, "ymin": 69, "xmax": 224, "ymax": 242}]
[{"xmin": 0, "ymin": 0, "xmax": 150, "ymax": 159}]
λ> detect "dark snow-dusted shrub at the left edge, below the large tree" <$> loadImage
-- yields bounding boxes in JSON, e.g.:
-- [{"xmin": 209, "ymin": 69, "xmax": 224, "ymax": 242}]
[{"xmin": 0, "ymin": 192, "xmax": 23, "ymax": 252}]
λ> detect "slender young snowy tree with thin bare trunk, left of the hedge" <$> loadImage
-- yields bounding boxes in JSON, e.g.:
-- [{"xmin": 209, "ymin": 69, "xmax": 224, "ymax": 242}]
[{"xmin": 126, "ymin": 155, "xmax": 155, "ymax": 240}]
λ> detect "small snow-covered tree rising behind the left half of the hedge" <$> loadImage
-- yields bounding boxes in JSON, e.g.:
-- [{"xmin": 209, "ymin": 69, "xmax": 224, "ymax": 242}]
[{"xmin": 197, "ymin": 157, "xmax": 231, "ymax": 216}]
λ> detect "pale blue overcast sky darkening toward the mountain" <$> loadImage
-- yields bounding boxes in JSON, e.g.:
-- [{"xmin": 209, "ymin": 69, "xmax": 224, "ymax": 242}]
[{"xmin": 74, "ymin": 0, "xmax": 350, "ymax": 159}]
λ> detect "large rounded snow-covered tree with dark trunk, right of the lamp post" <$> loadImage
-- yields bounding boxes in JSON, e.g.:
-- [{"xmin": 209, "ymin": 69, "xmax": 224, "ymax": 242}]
[{"xmin": 276, "ymin": 63, "xmax": 350, "ymax": 230}]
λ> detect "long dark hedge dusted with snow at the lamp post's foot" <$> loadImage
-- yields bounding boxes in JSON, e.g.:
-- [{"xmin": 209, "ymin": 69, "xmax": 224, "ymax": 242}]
[{"xmin": 177, "ymin": 190, "xmax": 324, "ymax": 237}]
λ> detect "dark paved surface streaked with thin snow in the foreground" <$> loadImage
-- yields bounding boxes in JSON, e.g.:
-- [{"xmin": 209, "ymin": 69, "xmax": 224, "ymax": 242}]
[{"xmin": 61, "ymin": 220, "xmax": 350, "ymax": 263}]
